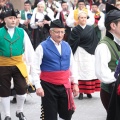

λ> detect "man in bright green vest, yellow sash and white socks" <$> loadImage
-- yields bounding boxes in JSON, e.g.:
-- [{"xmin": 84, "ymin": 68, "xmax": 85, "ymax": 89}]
[{"xmin": 0, "ymin": 9, "xmax": 34, "ymax": 120}]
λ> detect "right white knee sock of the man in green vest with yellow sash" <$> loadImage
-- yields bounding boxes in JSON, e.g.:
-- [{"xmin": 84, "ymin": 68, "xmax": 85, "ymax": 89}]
[{"xmin": 16, "ymin": 94, "xmax": 26, "ymax": 113}]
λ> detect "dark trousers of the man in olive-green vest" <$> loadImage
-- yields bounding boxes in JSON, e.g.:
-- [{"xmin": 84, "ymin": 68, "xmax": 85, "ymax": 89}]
[{"xmin": 100, "ymin": 89, "xmax": 111, "ymax": 111}]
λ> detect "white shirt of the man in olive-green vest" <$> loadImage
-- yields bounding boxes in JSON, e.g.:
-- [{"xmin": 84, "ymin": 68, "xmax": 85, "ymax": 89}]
[{"xmin": 95, "ymin": 38, "xmax": 120, "ymax": 84}]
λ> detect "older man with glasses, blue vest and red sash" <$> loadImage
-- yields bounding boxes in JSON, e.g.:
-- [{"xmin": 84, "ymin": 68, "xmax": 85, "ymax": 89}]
[{"xmin": 32, "ymin": 19, "xmax": 79, "ymax": 120}]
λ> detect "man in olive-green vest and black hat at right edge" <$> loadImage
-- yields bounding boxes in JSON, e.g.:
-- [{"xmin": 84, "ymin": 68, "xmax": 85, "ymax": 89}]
[{"xmin": 95, "ymin": 3, "xmax": 120, "ymax": 111}]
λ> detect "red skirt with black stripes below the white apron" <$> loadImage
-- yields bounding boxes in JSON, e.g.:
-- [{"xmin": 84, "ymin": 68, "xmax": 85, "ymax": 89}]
[{"xmin": 72, "ymin": 79, "xmax": 100, "ymax": 94}]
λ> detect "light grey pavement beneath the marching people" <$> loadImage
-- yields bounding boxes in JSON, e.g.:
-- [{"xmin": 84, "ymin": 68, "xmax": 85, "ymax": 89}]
[{"xmin": 0, "ymin": 92, "xmax": 106, "ymax": 120}]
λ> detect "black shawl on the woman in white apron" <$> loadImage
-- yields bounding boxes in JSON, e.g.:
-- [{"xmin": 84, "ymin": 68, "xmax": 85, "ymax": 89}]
[{"xmin": 69, "ymin": 25, "xmax": 99, "ymax": 54}]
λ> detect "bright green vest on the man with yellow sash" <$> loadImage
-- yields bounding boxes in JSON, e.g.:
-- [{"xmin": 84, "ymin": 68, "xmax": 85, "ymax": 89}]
[{"xmin": 0, "ymin": 27, "xmax": 24, "ymax": 57}]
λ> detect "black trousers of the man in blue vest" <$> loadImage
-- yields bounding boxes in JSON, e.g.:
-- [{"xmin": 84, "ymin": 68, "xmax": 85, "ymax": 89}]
[{"xmin": 41, "ymin": 80, "xmax": 74, "ymax": 120}]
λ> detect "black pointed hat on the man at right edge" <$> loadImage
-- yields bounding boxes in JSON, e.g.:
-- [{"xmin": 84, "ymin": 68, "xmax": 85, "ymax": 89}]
[{"xmin": 105, "ymin": 4, "xmax": 120, "ymax": 26}]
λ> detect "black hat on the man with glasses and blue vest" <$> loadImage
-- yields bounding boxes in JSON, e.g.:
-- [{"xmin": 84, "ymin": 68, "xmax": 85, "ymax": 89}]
[{"xmin": 50, "ymin": 19, "xmax": 65, "ymax": 28}]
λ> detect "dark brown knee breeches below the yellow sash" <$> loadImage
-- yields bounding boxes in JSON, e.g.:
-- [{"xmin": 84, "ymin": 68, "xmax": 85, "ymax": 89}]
[{"xmin": 0, "ymin": 66, "xmax": 27, "ymax": 97}]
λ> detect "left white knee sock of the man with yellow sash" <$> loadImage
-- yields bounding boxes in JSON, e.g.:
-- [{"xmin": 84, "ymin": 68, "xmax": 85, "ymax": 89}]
[{"xmin": 1, "ymin": 97, "xmax": 10, "ymax": 117}]
